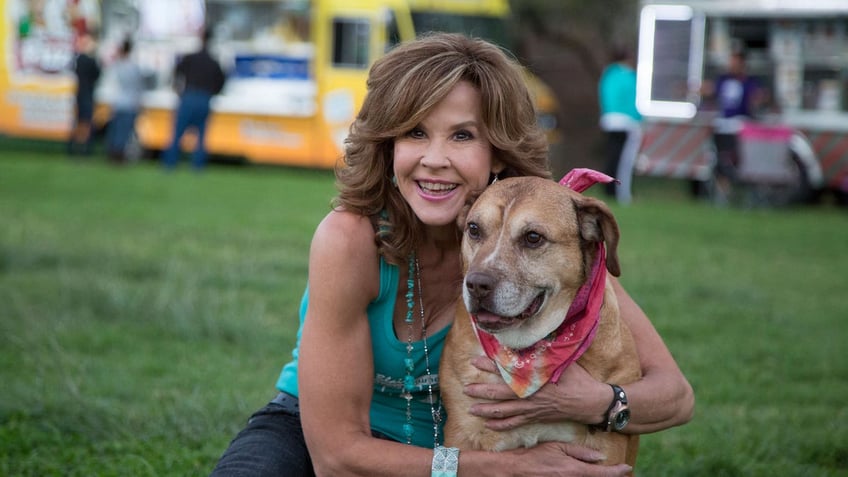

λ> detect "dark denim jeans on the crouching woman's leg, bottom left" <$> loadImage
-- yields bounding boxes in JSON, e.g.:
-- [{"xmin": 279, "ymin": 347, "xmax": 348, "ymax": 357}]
[{"xmin": 211, "ymin": 393, "xmax": 315, "ymax": 477}]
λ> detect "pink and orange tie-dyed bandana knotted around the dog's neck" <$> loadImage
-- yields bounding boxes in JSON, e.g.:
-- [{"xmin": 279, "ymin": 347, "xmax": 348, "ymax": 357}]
[{"xmin": 471, "ymin": 169, "xmax": 615, "ymax": 398}]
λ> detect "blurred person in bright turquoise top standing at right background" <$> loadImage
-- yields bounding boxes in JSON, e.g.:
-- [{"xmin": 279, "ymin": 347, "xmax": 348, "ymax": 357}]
[{"xmin": 598, "ymin": 45, "xmax": 642, "ymax": 204}]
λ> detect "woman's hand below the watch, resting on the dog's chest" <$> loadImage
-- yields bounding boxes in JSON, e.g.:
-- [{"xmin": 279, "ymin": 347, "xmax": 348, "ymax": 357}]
[{"xmin": 464, "ymin": 356, "xmax": 612, "ymax": 431}]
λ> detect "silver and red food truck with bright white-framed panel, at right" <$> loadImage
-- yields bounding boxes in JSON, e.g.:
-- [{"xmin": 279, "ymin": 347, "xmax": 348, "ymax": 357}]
[{"xmin": 633, "ymin": 0, "xmax": 848, "ymax": 203}]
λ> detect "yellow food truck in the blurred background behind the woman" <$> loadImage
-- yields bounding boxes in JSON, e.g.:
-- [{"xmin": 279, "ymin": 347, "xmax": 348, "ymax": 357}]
[{"xmin": 0, "ymin": 0, "xmax": 558, "ymax": 168}]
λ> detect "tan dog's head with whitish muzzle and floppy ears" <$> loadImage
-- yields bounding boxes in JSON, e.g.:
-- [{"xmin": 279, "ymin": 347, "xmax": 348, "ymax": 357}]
[{"xmin": 459, "ymin": 177, "xmax": 619, "ymax": 349}]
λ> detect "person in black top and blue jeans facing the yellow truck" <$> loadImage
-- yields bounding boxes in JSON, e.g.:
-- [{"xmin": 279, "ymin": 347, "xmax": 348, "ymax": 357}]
[{"xmin": 163, "ymin": 30, "xmax": 226, "ymax": 170}]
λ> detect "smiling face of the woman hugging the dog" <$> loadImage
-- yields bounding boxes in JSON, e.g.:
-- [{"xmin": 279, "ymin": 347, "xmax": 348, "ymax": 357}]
[{"xmin": 394, "ymin": 81, "xmax": 500, "ymax": 226}]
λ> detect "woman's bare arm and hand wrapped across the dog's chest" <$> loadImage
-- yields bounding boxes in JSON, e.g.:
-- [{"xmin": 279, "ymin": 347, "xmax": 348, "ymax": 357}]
[{"xmin": 466, "ymin": 277, "xmax": 695, "ymax": 434}]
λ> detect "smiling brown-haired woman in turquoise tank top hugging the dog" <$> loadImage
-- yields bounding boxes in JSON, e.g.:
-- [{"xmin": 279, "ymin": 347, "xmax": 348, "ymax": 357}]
[{"xmin": 209, "ymin": 34, "xmax": 693, "ymax": 476}]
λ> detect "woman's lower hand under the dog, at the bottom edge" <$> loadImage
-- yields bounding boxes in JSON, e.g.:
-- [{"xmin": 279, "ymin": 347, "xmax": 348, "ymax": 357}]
[{"xmin": 500, "ymin": 442, "xmax": 633, "ymax": 477}]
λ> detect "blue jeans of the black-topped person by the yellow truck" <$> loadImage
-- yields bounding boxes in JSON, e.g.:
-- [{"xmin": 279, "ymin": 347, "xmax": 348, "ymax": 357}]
[{"xmin": 163, "ymin": 90, "xmax": 212, "ymax": 169}]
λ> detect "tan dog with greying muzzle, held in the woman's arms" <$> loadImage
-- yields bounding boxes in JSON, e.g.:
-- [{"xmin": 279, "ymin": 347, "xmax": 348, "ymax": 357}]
[{"xmin": 439, "ymin": 177, "xmax": 640, "ymax": 466}]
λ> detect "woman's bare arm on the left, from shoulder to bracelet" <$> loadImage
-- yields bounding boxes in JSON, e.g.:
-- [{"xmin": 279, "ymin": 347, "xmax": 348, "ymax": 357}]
[{"xmin": 298, "ymin": 212, "xmax": 408, "ymax": 475}]
